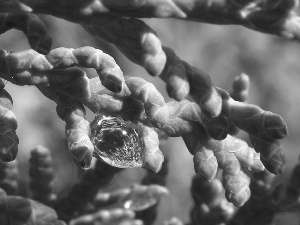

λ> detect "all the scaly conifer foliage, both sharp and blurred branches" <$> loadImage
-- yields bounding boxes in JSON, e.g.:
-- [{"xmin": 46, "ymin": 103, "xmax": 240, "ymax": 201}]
[{"xmin": 0, "ymin": 0, "xmax": 300, "ymax": 225}]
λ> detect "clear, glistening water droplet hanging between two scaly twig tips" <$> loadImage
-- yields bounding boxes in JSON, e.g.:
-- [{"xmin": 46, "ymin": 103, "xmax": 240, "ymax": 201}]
[{"xmin": 91, "ymin": 114, "xmax": 144, "ymax": 168}]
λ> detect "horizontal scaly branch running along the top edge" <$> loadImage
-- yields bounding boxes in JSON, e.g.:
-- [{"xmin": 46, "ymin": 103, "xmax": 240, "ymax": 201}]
[{"xmin": 8, "ymin": 0, "xmax": 300, "ymax": 39}]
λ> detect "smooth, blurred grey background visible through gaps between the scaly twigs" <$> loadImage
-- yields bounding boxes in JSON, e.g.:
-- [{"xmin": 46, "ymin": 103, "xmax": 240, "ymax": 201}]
[{"xmin": 0, "ymin": 13, "xmax": 300, "ymax": 224}]
